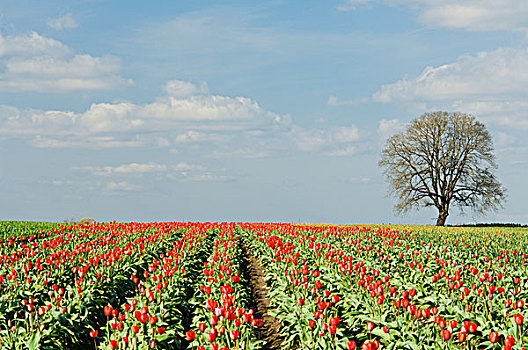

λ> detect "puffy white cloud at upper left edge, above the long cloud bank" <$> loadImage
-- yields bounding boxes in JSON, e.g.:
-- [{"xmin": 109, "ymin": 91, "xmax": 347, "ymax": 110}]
[{"xmin": 0, "ymin": 32, "xmax": 132, "ymax": 93}]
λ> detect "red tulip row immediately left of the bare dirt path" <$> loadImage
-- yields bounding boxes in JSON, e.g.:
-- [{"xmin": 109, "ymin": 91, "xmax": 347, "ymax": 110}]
[{"xmin": 186, "ymin": 224, "xmax": 263, "ymax": 350}]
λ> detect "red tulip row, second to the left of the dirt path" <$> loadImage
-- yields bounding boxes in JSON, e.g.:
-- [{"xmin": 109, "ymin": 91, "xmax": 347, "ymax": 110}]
[{"xmin": 96, "ymin": 225, "xmax": 218, "ymax": 349}]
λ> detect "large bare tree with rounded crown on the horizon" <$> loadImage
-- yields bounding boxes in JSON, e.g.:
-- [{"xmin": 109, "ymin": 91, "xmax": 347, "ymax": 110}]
[{"xmin": 379, "ymin": 112, "xmax": 505, "ymax": 226}]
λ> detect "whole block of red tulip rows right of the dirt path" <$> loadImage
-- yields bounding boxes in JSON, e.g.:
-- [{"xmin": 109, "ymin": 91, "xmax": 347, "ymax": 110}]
[{"xmin": 237, "ymin": 224, "xmax": 526, "ymax": 349}]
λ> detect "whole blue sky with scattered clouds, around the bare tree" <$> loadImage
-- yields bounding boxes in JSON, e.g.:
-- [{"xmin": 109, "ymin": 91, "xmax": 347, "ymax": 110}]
[{"xmin": 0, "ymin": 0, "xmax": 528, "ymax": 224}]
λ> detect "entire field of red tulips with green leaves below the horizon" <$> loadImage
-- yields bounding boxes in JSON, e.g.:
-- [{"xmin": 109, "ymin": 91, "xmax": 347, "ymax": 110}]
[{"xmin": 0, "ymin": 222, "xmax": 528, "ymax": 350}]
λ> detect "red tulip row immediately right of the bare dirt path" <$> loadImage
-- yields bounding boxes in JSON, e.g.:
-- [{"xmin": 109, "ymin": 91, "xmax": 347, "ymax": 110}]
[{"xmin": 239, "ymin": 225, "xmax": 355, "ymax": 349}]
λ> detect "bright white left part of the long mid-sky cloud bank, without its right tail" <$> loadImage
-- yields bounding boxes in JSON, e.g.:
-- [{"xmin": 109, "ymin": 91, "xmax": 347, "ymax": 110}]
[{"xmin": 0, "ymin": 80, "xmax": 291, "ymax": 147}]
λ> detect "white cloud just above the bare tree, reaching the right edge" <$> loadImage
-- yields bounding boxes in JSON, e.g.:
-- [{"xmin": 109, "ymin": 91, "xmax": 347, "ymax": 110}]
[{"xmin": 373, "ymin": 48, "xmax": 528, "ymax": 132}]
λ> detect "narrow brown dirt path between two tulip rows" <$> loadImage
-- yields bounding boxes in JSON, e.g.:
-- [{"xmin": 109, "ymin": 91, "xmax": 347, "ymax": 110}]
[{"xmin": 241, "ymin": 243, "xmax": 282, "ymax": 350}]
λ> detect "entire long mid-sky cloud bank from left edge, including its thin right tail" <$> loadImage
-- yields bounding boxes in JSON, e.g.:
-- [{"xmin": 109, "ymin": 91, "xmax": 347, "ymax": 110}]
[{"xmin": 0, "ymin": 76, "xmax": 360, "ymax": 157}]
